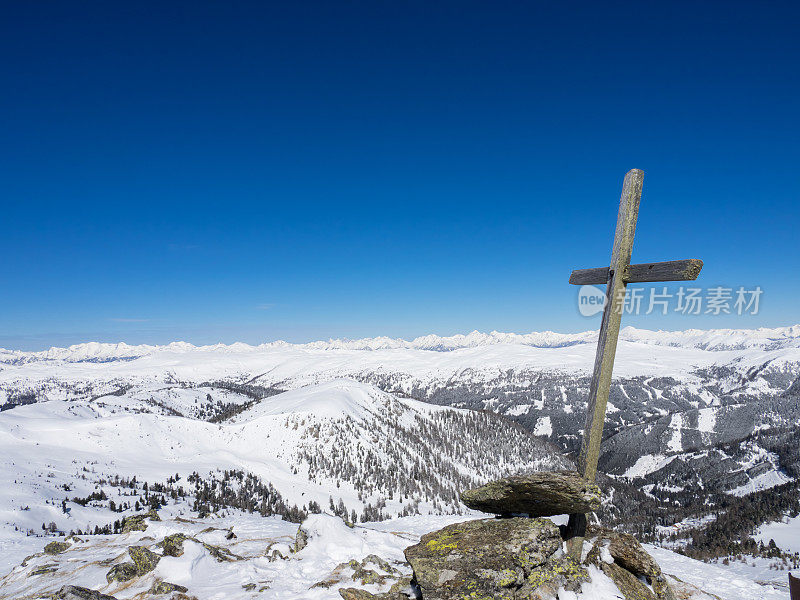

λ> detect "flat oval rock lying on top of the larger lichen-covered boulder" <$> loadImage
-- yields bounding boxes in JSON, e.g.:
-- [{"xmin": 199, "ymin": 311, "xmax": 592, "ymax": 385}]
[{"xmin": 461, "ymin": 471, "xmax": 600, "ymax": 517}]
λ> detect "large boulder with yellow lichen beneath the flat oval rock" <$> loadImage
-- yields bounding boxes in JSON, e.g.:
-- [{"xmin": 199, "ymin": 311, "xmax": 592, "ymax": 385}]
[{"xmin": 405, "ymin": 518, "xmax": 589, "ymax": 600}]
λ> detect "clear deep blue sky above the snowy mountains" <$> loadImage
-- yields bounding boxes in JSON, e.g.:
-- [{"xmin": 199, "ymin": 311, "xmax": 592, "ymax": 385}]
[{"xmin": 0, "ymin": 1, "xmax": 800, "ymax": 349}]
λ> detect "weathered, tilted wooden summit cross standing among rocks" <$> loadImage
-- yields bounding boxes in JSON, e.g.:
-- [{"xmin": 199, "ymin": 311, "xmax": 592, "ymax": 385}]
[{"xmin": 567, "ymin": 169, "xmax": 703, "ymax": 560}]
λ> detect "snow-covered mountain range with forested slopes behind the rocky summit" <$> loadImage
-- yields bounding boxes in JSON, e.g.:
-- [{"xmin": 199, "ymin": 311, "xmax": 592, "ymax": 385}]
[{"xmin": 0, "ymin": 325, "xmax": 800, "ymax": 600}]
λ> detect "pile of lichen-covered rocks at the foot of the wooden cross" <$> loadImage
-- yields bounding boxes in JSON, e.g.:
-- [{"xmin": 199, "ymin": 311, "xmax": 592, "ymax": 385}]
[{"xmin": 342, "ymin": 471, "xmax": 675, "ymax": 600}]
